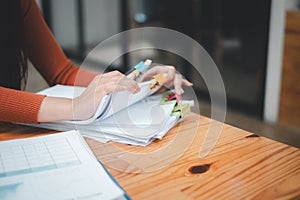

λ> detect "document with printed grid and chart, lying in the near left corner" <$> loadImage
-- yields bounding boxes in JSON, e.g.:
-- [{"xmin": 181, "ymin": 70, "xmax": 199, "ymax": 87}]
[{"xmin": 0, "ymin": 131, "xmax": 129, "ymax": 200}]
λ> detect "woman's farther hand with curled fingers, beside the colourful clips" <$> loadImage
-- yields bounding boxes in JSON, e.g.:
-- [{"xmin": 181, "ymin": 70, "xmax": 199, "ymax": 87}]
[{"xmin": 139, "ymin": 65, "xmax": 193, "ymax": 95}]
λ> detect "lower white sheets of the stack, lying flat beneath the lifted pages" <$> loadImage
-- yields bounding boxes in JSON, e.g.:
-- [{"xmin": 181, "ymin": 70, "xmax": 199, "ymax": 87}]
[{"xmin": 27, "ymin": 95, "xmax": 179, "ymax": 146}]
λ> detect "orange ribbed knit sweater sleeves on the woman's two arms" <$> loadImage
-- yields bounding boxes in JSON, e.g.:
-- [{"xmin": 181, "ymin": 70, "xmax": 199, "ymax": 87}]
[{"xmin": 0, "ymin": 0, "xmax": 96, "ymax": 123}]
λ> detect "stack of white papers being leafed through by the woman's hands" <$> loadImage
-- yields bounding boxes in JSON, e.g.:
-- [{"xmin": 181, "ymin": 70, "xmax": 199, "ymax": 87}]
[{"xmin": 27, "ymin": 82, "xmax": 193, "ymax": 146}]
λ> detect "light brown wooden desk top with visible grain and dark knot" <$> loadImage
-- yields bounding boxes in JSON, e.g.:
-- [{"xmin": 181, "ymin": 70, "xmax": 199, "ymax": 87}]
[{"xmin": 0, "ymin": 114, "xmax": 300, "ymax": 199}]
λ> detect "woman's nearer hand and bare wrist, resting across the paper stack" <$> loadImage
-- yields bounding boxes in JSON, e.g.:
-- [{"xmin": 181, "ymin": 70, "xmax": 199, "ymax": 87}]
[{"xmin": 38, "ymin": 71, "xmax": 140, "ymax": 122}]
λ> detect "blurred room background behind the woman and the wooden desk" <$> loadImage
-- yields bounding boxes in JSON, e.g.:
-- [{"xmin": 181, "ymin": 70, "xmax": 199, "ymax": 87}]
[{"xmin": 27, "ymin": 0, "xmax": 300, "ymax": 147}]
